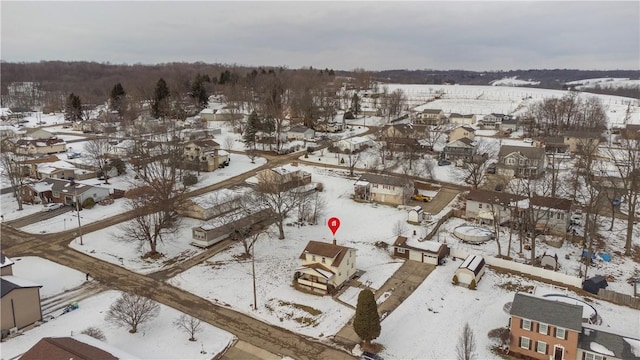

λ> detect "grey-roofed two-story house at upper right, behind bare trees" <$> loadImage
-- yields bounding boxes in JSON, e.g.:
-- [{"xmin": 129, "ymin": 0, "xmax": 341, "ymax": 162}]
[{"xmin": 496, "ymin": 145, "xmax": 546, "ymax": 178}]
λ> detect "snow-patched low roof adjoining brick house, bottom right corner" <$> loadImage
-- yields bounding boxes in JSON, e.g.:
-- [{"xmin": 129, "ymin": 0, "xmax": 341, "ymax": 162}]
[{"xmin": 578, "ymin": 325, "xmax": 640, "ymax": 360}]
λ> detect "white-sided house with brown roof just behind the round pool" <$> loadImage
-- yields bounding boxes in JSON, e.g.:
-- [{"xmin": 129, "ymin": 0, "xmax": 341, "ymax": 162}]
[{"xmin": 465, "ymin": 189, "xmax": 525, "ymax": 225}]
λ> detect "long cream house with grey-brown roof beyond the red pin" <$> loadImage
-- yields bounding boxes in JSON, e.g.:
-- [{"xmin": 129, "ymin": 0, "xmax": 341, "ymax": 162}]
[{"xmin": 354, "ymin": 173, "xmax": 414, "ymax": 205}]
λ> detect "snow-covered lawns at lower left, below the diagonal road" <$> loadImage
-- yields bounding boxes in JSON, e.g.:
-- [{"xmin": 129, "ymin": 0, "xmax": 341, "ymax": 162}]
[{"xmin": 1, "ymin": 256, "xmax": 234, "ymax": 359}]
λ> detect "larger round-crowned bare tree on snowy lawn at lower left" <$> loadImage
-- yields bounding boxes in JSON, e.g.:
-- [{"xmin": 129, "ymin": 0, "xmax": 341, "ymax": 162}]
[{"xmin": 105, "ymin": 293, "xmax": 160, "ymax": 334}]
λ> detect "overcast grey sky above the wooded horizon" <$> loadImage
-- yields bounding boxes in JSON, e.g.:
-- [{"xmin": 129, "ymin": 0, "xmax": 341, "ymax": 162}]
[{"xmin": 0, "ymin": 1, "xmax": 640, "ymax": 70}]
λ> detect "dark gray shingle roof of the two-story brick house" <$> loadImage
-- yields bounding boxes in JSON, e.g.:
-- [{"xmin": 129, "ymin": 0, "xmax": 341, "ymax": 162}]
[{"xmin": 511, "ymin": 293, "xmax": 582, "ymax": 332}]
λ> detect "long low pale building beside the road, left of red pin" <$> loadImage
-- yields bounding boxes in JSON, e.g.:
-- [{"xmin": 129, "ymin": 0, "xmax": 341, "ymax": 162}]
[{"xmin": 191, "ymin": 207, "xmax": 274, "ymax": 248}]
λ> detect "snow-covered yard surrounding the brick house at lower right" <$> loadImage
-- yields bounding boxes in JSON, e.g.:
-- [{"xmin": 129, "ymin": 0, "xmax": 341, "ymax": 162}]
[{"xmin": 375, "ymin": 260, "xmax": 640, "ymax": 359}]
